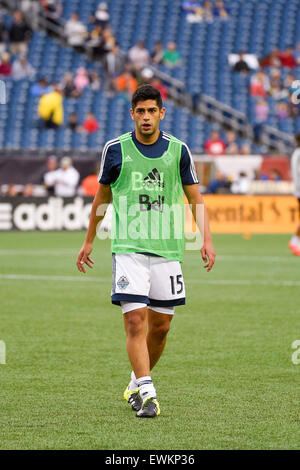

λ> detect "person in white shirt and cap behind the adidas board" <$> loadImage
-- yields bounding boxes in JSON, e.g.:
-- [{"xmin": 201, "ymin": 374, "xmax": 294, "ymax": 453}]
[{"xmin": 44, "ymin": 157, "xmax": 79, "ymax": 197}]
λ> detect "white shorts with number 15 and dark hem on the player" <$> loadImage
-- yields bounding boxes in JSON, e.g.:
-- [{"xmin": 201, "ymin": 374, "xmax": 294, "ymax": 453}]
[{"xmin": 111, "ymin": 253, "xmax": 185, "ymax": 309}]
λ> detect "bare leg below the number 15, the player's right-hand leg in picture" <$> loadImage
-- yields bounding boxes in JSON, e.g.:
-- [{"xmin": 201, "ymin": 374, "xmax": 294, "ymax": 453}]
[{"xmin": 147, "ymin": 307, "xmax": 174, "ymax": 370}]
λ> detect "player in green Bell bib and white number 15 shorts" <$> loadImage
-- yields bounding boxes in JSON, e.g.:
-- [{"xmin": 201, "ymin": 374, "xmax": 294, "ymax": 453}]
[{"xmin": 77, "ymin": 85, "xmax": 215, "ymax": 418}]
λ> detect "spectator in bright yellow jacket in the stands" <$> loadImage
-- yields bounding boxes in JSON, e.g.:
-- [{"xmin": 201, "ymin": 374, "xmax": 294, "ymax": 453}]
[{"xmin": 38, "ymin": 84, "xmax": 64, "ymax": 129}]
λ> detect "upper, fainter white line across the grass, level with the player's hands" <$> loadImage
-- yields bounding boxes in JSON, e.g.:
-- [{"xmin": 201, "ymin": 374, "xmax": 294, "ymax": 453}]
[{"xmin": 0, "ymin": 248, "xmax": 300, "ymax": 263}]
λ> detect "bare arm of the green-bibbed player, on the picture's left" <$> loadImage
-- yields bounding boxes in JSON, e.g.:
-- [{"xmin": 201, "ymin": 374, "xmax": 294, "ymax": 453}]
[{"xmin": 76, "ymin": 183, "xmax": 112, "ymax": 273}]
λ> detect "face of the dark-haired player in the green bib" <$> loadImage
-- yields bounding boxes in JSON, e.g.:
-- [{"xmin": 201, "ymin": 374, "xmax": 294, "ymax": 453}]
[{"xmin": 130, "ymin": 100, "xmax": 165, "ymax": 140}]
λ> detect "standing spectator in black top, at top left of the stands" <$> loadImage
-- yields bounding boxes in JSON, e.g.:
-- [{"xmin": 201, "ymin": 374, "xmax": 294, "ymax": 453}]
[{"xmin": 9, "ymin": 10, "xmax": 31, "ymax": 55}]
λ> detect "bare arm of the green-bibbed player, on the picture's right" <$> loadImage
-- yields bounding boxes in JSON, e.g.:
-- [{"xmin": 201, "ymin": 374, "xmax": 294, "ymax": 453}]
[{"xmin": 183, "ymin": 184, "xmax": 216, "ymax": 271}]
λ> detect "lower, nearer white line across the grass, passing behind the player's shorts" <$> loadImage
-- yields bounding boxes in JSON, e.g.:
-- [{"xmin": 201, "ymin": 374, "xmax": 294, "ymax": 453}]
[{"xmin": 0, "ymin": 274, "xmax": 300, "ymax": 287}]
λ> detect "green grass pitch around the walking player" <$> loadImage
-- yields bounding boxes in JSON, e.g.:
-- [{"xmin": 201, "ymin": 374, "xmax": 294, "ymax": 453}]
[{"xmin": 0, "ymin": 233, "xmax": 300, "ymax": 450}]
